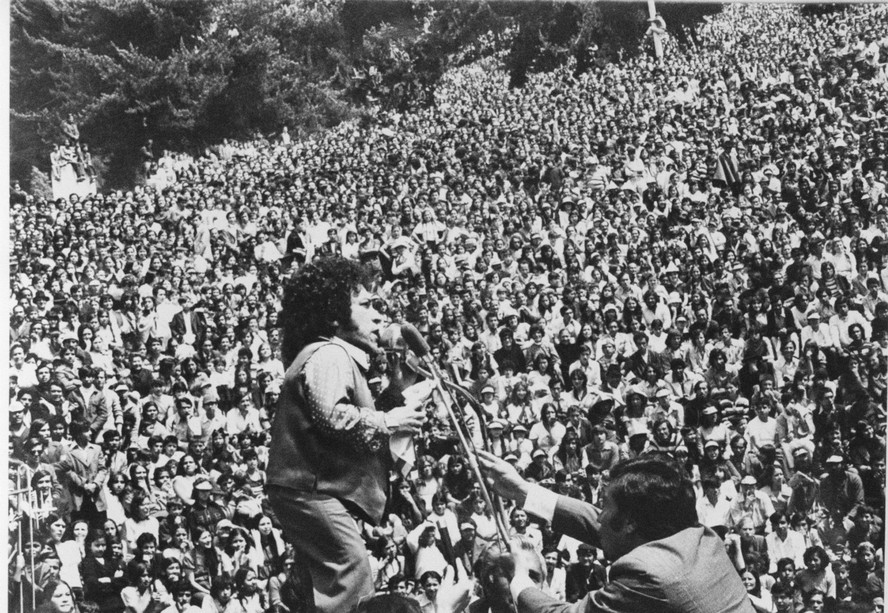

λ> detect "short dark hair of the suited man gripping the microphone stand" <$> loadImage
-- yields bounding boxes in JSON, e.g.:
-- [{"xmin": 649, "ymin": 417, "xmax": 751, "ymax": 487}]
[{"xmin": 608, "ymin": 453, "xmax": 698, "ymax": 541}]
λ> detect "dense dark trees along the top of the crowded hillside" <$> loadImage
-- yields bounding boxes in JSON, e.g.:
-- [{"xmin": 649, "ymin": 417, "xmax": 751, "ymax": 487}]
[{"xmin": 10, "ymin": 0, "xmax": 724, "ymax": 185}]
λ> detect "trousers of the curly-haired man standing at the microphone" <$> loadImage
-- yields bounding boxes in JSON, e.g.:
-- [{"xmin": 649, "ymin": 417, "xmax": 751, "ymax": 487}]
[{"xmin": 268, "ymin": 487, "xmax": 374, "ymax": 613}]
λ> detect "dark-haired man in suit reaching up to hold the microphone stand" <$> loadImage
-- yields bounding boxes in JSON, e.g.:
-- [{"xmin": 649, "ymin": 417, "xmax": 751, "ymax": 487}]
[{"xmin": 479, "ymin": 451, "xmax": 754, "ymax": 613}]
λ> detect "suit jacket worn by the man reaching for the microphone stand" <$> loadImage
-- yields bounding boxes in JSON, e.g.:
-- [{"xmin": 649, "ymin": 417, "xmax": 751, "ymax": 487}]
[{"xmin": 518, "ymin": 496, "xmax": 754, "ymax": 613}]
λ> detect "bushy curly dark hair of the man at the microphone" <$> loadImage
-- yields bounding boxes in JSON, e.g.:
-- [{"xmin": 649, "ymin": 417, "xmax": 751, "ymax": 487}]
[{"xmin": 278, "ymin": 257, "xmax": 370, "ymax": 366}]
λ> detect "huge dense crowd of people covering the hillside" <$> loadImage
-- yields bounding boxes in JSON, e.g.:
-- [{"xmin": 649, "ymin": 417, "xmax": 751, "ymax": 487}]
[{"xmin": 9, "ymin": 5, "xmax": 888, "ymax": 613}]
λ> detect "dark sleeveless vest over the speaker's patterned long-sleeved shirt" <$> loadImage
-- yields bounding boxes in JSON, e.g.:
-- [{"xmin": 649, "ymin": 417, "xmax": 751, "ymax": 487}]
[{"xmin": 267, "ymin": 341, "xmax": 391, "ymax": 524}]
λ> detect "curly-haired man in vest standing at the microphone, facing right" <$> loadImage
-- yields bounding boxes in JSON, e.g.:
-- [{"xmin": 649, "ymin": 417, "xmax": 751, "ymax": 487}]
[{"xmin": 267, "ymin": 257, "xmax": 425, "ymax": 612}]
